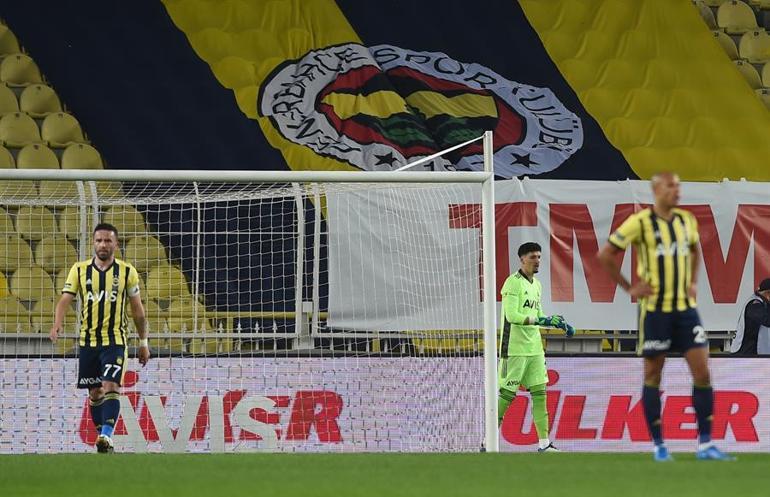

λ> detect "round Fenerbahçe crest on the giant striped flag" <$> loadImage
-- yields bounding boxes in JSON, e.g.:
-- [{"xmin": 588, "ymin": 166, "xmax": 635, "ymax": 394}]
[{"xmin": 257, "ymin": 43, "xmax": 583, "ymax": 178}]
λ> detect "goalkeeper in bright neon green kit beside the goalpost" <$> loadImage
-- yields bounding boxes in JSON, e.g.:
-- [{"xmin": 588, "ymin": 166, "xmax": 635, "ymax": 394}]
[{"xmin": 497, "ymin": 242, "xmax": 575, "ymax": 452}]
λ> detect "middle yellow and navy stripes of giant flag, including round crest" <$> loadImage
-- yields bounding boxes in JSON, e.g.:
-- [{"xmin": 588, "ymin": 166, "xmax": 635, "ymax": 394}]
[{"xmin": 159, "ymin": 0, "xmax": 636, "ymax": 179}]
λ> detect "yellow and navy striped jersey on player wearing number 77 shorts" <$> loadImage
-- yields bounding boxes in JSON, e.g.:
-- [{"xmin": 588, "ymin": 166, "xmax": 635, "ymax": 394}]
[{"xmin": 62, "ymin": 259, "xmax": 139, "ymax": 347}]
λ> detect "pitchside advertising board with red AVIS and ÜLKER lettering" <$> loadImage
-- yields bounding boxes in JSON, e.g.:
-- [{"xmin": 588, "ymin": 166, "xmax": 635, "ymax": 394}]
[{"xmin": 0, "ymin": 357, "xmax": 770, "ymax": 454}]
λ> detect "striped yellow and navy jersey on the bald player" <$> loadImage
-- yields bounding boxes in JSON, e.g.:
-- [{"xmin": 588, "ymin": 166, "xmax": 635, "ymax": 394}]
[{"xmin": 609, "ymin": 208, "xmax": 698, "ymax": 312}]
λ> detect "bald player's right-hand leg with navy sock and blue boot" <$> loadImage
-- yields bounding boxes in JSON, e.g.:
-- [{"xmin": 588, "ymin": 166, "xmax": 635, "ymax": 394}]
[{"xmin": 684, "ymin": 347, "xmax": 734, "ymax": 461}]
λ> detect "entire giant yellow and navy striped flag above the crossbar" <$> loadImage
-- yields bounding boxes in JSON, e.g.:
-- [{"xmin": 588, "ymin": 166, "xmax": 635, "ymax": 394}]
[{"xmin": 4, "ymin": 0, "xmax": 770, "ymax": 181}]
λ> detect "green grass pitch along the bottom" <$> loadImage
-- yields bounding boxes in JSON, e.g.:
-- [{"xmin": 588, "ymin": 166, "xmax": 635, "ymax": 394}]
[{"xmin": 0, "ymin": 453, "xmax": 770, "ymax": 497}]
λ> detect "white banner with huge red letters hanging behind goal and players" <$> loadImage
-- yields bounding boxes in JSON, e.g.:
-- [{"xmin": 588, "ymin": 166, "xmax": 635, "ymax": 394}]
[{"xmin": 329, "ymin": 179, "xmax": 770, "ymax": 330}]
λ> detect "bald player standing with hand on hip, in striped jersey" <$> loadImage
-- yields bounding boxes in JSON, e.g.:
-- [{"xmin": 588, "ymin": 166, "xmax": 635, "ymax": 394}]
[{"xmin": 599, "ymin": 172, "xmax": 733, "ymax": 461}]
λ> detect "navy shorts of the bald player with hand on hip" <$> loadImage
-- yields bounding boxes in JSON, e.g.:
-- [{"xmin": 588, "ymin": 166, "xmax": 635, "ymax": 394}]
[{"xmin": 638, "ymin": 309, "xmax": 708, "ymax": 357}]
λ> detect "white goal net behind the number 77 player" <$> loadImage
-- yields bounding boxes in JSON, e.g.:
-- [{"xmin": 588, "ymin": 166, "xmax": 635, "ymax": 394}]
[{"xmin": 0, "ymin": 158, "xmax": 496, "ymax": 453}]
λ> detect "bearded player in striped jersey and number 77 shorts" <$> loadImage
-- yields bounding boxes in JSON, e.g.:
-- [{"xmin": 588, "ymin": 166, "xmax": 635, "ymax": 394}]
[{"xmin": 50, "ymin": 224, "xmax": 150, "ymax": 453}]
